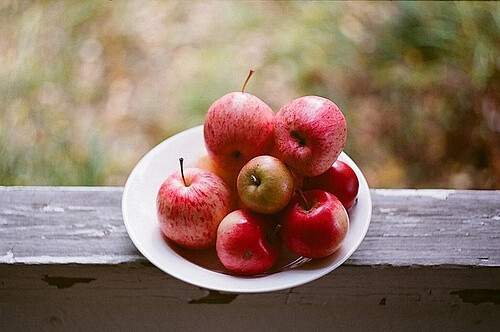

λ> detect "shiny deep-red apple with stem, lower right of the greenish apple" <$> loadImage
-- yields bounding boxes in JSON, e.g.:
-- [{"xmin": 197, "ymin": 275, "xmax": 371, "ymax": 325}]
[{"xmin": 281, "ymin": 190, "xmax": 349, "ymax": 258}]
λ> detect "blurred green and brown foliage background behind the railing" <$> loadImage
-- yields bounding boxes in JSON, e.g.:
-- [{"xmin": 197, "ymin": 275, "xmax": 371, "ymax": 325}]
[{"xmin": 0, "ymin": 0, "xmax": 500, "ymax": 189}]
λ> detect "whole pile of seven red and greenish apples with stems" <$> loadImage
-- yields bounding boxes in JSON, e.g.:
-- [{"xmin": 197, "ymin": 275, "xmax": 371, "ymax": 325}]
[{"xmin": 157, "ymin": 71, "xmax": 359, "ymax": 275}]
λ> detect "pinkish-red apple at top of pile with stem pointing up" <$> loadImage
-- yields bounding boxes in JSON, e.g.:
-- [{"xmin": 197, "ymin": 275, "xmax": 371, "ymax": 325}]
[{"xmin": 203, "ymin": 92, "xmax": 274, "ymax": 171}]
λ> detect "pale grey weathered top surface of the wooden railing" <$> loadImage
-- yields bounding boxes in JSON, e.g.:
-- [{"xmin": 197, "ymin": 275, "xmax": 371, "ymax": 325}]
[{"xmin": 0, "ymin": 187, "xmax": 500, "ymax": 267}]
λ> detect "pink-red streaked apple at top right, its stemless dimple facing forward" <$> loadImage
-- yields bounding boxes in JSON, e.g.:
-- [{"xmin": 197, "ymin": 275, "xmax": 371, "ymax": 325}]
[{"xmin": 274, "ymin": 96, "xmax": 347, "ymax": 177}]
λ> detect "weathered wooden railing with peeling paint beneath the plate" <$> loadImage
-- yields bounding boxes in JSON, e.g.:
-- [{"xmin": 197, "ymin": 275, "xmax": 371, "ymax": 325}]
[{"xmin": 0, "ymin": 187, "xmax": 500, "ymax": 331}]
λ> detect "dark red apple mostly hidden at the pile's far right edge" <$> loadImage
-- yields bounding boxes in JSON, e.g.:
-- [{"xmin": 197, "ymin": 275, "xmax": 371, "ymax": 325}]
[{"xmin": 304, "ymin": 160, "xmax": 359, "ymax": 210}]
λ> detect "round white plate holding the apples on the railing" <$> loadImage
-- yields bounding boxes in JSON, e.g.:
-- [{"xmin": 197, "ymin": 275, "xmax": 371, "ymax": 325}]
[{"xmin": 122, "ymin": 126, "xmax": 372, "ymax": 293}]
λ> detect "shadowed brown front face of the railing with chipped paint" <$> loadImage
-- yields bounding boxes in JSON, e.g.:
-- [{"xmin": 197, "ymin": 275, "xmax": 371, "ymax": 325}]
[{"xmin": 0, "ymin": 264, "xmax": 500, "ymax": 331}]
